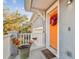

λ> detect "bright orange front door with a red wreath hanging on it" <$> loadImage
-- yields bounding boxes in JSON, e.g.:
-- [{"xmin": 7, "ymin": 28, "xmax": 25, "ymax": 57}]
[{"xmin": 49, "ymin": 8, "xmax": 58, "ymax": 49}]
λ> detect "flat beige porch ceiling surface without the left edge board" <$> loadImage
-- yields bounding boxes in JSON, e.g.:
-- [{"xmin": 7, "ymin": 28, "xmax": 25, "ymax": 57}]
[{"xmin": 31, "ymin": 0, "xmax": 55, "ymax": 10}]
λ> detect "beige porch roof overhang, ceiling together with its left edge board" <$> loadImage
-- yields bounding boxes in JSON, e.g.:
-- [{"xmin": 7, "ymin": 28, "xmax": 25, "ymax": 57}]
[{"xmin": 25, "ymin": 0, "xmax": 56, "ymax": 11}]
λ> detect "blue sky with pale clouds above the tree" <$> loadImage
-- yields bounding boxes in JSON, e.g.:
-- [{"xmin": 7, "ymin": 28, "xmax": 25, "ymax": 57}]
[{"xmin": 3, "ymin": 0, "xmax": 33, "ymax": 19}]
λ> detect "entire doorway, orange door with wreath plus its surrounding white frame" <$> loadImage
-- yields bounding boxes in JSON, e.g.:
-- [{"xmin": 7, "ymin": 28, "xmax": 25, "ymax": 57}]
[{"xmin": 46, "ymin": 1, "xmax": 59, "ymax": 57}]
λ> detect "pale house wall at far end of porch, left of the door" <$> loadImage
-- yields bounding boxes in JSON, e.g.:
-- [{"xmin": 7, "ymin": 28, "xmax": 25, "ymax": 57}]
[{"xmin": 31, "ymin": 16, "xmax": 45, "ymax": 50}]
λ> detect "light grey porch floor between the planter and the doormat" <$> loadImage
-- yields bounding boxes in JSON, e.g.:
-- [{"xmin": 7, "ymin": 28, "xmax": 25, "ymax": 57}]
[{"xmin": 15, "ymin": 48, "xmax": 57, "ymax": 59}]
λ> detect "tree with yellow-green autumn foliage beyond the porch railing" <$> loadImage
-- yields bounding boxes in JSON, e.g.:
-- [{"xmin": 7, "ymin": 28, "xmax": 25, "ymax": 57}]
[{"xmin": 3, "ymin": 11, "xmax": 28, "ymax": 34}]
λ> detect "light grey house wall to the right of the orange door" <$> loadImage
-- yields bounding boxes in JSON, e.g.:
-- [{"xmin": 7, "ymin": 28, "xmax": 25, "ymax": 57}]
[{"xmin": 59, "ymin": 0, "xmax": 75, "ymax": 59}]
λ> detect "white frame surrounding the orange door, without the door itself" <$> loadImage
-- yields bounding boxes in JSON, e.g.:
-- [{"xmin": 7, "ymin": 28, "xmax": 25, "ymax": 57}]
[{"xmin": 46, "ymin": 1, "xmax": 59, "ymax": 58}]
